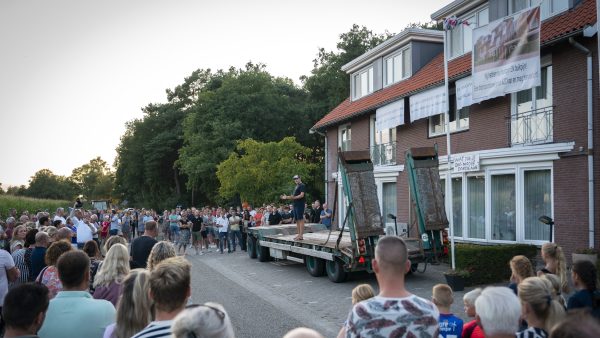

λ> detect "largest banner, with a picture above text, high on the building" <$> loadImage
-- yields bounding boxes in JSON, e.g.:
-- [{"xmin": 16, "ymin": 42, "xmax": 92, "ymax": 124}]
[{"xmin": 472, "ymin": 6, "xmax": 541, "ymax": 103}]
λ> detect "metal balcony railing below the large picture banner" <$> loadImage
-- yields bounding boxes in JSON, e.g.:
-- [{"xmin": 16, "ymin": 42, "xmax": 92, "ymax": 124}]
[{"xmin": 508, "ymin": 106, "xmax": 554, "ymax": 146}]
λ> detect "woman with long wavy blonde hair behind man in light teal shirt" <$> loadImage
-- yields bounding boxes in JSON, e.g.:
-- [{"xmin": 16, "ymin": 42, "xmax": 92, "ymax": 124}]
[{"xmin": 94, "ymin": 243, "xmax": 129, "ymax": 306}]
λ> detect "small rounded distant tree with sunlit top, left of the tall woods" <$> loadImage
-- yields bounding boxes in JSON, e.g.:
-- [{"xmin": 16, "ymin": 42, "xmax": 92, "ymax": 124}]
[{"xmin": 70, "ymin": 157, "xmax": 114, "ymax": 200}]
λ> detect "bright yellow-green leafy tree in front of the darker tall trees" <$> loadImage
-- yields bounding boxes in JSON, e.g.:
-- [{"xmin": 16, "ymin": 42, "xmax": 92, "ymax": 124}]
[{"xmin": 217, "ymin": 137, "xmax": 315, "ymax": 205}]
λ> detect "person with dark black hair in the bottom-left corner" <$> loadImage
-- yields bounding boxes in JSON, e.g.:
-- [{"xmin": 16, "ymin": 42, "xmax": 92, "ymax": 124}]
[{"xmin": 2, "ymin": 283, "xmax": 50, "ymax": 338}]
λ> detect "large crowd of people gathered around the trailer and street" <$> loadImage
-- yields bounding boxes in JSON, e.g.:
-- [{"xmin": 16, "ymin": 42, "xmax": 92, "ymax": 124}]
[{"xmin": 0, "ymin": 201, "xmax": 600, "ymax": 338}]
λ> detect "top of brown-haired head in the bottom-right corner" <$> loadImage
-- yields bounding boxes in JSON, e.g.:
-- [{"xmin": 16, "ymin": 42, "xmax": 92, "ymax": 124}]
[{"xmin": 550, "ymin": 309, "xmax": 600, "ymax": 338}]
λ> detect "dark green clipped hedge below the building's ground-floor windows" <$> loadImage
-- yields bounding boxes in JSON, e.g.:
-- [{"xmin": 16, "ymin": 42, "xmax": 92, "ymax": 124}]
[{"xmin": 456, "ymin": 244, "xmax": 538, "ymax": 285}]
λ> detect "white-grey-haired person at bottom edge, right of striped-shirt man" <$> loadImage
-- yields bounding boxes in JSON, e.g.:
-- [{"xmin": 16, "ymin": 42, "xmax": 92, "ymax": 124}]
[{"xmin": 171, "ymin": 303, "xmax": 235, "ymax": 338}]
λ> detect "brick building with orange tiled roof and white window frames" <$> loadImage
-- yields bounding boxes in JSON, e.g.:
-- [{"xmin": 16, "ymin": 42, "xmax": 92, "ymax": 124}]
[{"xmin": 313, "ymin": 0, "xmax": 600, "ymax": 252}]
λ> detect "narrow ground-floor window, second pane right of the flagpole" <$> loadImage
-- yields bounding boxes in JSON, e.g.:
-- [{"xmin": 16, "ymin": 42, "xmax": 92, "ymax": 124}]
[{"xmin": 467, "ymin": 175, "xmax": 485, "ymax": 239}]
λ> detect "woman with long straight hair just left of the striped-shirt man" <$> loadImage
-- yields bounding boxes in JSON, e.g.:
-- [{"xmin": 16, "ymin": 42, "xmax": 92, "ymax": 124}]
[{"xmin": 104, "ymin": 269, "xmax": 152, "ymax": 338}]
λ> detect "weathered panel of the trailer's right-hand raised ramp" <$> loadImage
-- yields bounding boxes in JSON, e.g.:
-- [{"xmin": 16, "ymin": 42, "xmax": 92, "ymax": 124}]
[{"xmin": 415, "ymin": 166, "xmax": 448, "ymax": 230}]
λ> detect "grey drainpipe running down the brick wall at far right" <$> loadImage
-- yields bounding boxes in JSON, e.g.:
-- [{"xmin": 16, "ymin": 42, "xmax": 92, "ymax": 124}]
[{"xmin": 569, "ymin": 38, "xmax": 595, "ymax": 248}]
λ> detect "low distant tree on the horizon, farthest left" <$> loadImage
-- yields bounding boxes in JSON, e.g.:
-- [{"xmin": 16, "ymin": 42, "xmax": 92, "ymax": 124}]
[{"xmin": 25, "ymin": 169, "xmax": 79, "ymax": 200}]
